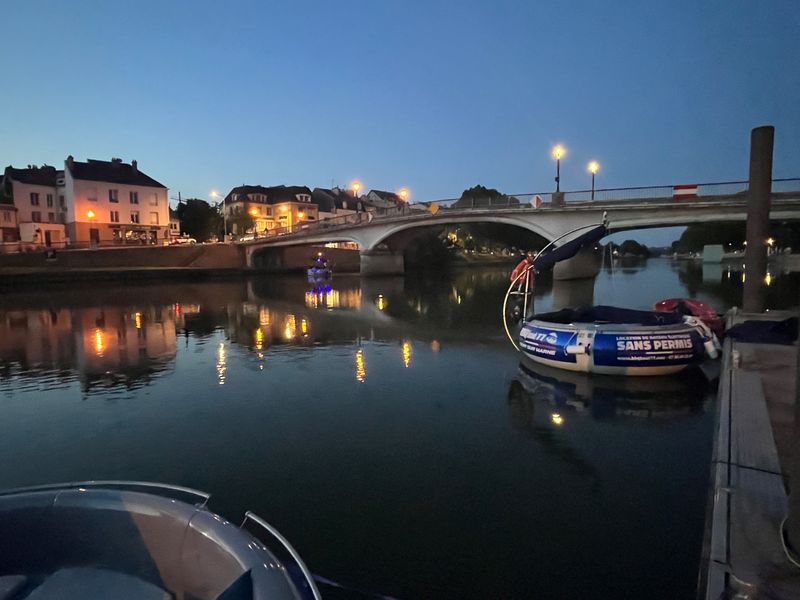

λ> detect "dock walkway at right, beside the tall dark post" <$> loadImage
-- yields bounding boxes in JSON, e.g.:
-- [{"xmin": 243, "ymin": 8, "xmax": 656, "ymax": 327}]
[{"xmin": 698, "ymin": 311, "xmax": 800, "ymax": 600}]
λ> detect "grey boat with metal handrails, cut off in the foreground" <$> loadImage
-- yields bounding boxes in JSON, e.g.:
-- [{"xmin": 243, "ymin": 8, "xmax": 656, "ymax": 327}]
[{"xmin": 0, "ymin": 482, "xmax": 320, "ymax": 600}]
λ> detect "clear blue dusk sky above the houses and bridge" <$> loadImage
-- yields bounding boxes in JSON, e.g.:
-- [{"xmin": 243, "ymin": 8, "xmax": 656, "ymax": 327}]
[{"xmin": 0, "ymin": 0, "xmax": 800, "ymax": 243}]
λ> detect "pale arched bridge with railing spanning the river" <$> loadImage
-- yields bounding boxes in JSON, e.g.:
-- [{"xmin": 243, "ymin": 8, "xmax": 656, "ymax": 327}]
[{"xmin": 242, "ymin": 185, "xmax": 800, "ymax": 275}]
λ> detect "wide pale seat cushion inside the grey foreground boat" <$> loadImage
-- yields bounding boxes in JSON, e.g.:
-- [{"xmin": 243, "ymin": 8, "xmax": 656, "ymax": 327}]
[{"xmin": 26, "ymin": 567, "xmax": 174, "ymax": 600}]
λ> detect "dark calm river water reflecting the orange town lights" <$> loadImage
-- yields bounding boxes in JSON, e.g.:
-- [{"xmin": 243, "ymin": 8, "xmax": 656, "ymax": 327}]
[{"xmin": 0, "ymin": 259, "xmax": 800, "ymax": 599}]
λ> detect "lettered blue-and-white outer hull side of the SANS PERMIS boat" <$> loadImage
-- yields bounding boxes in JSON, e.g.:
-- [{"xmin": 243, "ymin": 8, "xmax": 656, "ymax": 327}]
[{"xmin": 519, "ymin": 319, "xmax": 706, "ymax": 376}]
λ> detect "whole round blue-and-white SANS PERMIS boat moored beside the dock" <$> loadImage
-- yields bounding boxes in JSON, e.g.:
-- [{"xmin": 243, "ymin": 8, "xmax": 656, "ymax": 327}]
[{"xmin": 519, "ymin": 306, "xmax": 719, "ymax": 375}]
